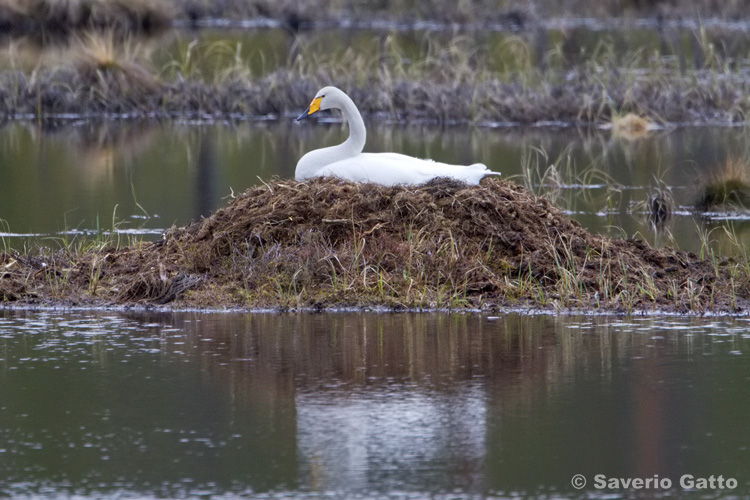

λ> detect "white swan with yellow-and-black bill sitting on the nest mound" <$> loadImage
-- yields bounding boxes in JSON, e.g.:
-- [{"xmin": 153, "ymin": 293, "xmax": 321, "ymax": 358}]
[{"xmin": 294, "ymin": 87, "xmax": 500, "ymax": 186}]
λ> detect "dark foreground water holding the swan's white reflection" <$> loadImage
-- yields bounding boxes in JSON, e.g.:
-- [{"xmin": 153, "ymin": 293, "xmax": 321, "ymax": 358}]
[{"xmin": 0, "ymin": 311, "xmax": 750, "ymax": 499}]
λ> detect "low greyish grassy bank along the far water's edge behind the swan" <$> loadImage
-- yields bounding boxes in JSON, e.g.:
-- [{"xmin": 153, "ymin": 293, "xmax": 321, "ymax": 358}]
[{"xmin": 0, "ymin": 63, "xmax": 750, "ymax": 126}]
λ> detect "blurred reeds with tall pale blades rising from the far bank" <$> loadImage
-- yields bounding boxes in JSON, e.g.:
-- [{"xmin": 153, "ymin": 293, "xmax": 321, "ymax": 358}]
[{"xmin": 0, "ymin": 26, "xmax": 750, "ymax": 125}]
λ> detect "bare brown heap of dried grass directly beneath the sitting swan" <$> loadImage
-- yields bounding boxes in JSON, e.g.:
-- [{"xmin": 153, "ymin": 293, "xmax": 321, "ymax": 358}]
[{"xmin": 162, "ymin": 179, "xmax": 591, "ymax": 278}]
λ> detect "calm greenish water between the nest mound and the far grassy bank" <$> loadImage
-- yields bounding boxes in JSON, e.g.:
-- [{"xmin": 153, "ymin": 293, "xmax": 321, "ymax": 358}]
[{"xmin": 0, "ymin": 120, "xmax": 750, "ymax": 254}]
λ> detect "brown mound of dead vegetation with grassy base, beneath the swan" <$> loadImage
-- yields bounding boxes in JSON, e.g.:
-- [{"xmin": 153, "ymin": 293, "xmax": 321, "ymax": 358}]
[{"xmin": 0, "ymin": 179, "xmax": 750, "ymax": 312}]
